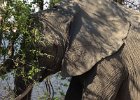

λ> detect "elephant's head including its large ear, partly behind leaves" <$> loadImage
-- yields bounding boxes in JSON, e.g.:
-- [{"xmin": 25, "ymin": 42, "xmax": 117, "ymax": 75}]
[{"xmin": 35, "ymin": 0, "xmax": 130, "ymax": 76}]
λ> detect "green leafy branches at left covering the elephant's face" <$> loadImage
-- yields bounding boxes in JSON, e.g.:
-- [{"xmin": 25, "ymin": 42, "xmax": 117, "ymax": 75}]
[{"xmin": 0, "ymin": 0, "xmax": 46, "ymax": 83}]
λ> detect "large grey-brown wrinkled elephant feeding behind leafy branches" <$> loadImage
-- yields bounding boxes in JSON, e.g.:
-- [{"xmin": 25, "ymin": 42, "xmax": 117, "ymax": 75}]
[{"xmin": 1, "ymin": 0, "xmax": 140, "ymax": 100}]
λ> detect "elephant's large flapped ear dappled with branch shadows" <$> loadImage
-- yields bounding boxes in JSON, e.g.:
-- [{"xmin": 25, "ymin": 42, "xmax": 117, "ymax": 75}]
[{"xmin": 62, "ymin": 0, "xmax": 130, "ymax": 76}]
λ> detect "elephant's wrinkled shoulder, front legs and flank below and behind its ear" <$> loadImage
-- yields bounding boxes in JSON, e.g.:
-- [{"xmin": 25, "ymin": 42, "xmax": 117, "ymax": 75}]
[{"xmin": 65, "ymin": 26, "xmax": 140, "ymax": 100}]
